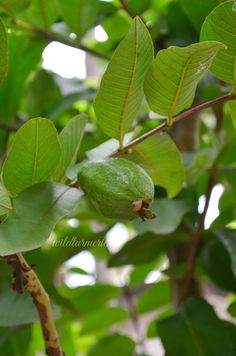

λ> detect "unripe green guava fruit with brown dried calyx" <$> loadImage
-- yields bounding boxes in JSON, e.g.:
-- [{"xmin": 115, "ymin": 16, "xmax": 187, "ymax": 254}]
[{"xmin": 78, "ymin": 158, "xmax": 155, "ymax": 220}]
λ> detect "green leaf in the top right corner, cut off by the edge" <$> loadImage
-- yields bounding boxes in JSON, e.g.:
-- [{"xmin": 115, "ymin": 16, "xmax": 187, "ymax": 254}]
[{"xmin": 201, "ymin": 1, "xmax": 236, "ymax": 83}]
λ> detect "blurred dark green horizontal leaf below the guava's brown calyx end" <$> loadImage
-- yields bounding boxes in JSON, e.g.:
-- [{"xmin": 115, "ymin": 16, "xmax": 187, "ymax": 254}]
[{"xmin": 108, "ymin": 231, "xmax": 189, "ymax": 267}]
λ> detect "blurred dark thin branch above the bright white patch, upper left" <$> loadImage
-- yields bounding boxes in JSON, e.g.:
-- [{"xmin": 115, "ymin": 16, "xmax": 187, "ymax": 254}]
[{"xmin": 12, "ymin": 20, "xmax": 110, "ymax": 60}]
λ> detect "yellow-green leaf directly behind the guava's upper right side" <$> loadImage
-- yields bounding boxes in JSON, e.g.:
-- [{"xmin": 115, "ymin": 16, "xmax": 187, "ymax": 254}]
[{"xmin": 127, "ymin": 133, "xmax": 184, "ymax": 198}]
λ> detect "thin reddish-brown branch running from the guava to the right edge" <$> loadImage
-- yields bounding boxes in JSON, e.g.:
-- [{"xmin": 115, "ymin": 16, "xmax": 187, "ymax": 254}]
[{"xmin": 110, "ymin": 93, "xmax": 236, "ymax": 157}]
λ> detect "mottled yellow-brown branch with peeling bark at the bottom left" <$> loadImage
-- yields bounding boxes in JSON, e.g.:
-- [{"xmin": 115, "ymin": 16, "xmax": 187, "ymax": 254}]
[{"xmin": 4, "ymin": 253, "xmax": 64, "ymax": 356}]
